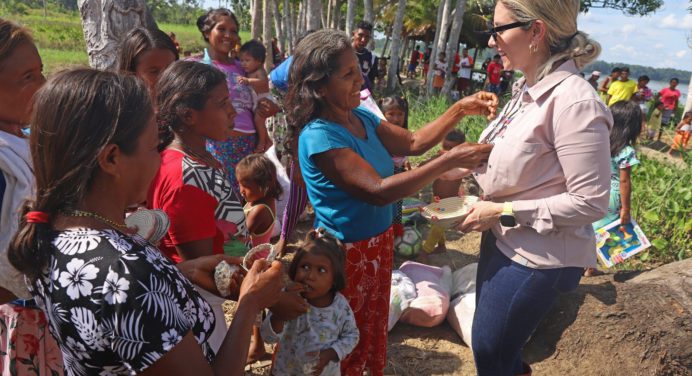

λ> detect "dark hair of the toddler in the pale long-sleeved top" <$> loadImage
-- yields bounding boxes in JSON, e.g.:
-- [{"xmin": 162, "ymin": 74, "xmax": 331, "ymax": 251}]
[{"xmin": 288, "ymin": 228, "xmax": 346, "ymax": 292}]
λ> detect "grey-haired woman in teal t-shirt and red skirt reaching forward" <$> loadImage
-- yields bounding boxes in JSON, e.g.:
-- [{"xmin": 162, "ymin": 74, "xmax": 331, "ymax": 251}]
[{"xmin": 285, "ymin": 30, "xmax": 497, "ymax": 375}]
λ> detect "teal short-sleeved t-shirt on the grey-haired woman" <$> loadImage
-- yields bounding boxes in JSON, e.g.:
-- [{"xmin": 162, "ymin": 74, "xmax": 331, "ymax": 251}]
[{"xmin": 298, "ymin": 107, "xmax": 394, "ymax": 243}]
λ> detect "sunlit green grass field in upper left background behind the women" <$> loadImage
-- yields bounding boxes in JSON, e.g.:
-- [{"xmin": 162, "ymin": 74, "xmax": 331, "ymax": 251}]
[{"xmin": 3, "ymin": 9, "xmax": 250, "ymax": 76}]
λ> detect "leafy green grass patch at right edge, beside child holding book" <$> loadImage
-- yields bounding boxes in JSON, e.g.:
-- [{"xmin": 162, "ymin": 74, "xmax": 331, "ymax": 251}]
[{"xmin": 632, "ymin": 154, "xmax": 692, "ymax": 263}]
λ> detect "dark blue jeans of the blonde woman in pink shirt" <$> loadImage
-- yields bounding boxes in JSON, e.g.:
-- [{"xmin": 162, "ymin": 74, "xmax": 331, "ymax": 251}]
[{"xmin": 472, "ymin": 231, "xmax": 584, "ymax": 376}]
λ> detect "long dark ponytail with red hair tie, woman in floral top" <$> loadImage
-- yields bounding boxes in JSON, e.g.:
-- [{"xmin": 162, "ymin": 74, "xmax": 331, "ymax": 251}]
[{"xmin": 8, "ymin": 69, "xmax": 153, "ymax": 278}]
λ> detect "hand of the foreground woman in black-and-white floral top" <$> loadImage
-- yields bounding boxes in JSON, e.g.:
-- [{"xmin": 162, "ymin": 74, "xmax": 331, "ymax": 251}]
[{"xmin": 238, "ymin": 259, "xmax": 284, "ymax": 311}]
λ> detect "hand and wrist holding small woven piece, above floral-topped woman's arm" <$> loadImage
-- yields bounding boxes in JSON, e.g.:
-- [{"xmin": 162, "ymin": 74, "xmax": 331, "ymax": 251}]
[{"xmin": 177, "ymin": 255, "xmax": 245, "ymax": 300}]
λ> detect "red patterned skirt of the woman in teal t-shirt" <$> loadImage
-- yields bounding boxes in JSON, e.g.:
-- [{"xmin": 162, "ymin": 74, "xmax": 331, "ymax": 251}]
[{"xmin": 341, "ymin": 227, "xmax": 394, "ymax": 376}]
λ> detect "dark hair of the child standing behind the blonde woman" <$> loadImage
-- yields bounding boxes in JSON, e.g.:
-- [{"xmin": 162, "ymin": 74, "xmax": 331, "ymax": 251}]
[{"xmin": 610, "ymin": 101, "xmax": 642, "ymax": 157}]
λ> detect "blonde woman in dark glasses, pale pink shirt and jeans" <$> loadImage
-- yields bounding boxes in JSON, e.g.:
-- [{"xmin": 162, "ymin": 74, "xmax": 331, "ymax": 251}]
[{"xmin": 460, "ymin": 0, "xmax": 613, "ymax": 376}]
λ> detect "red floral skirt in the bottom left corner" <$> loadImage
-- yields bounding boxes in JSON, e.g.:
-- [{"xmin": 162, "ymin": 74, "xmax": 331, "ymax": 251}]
[{"xmin": 0, "ymin": 304, "xmax": 63, "ymax": 376}]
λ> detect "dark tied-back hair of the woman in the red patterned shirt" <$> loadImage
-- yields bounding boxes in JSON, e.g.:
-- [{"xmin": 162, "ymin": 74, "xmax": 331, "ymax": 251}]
[{"xmin": 156, "ymin": 61, "xmax": 226, "ymax": 151}]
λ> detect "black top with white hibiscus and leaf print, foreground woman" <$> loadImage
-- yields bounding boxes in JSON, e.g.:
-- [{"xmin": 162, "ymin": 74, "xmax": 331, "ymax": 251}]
[{"xmin": 30, "ymin": 229, "xmax": 214, "ymax": 375}]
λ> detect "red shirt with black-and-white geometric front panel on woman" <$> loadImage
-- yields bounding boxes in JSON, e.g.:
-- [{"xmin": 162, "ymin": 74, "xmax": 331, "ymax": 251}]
[{"xmin": 147, "ymin": 149, "xmax": 247, "ymax": 263}]
